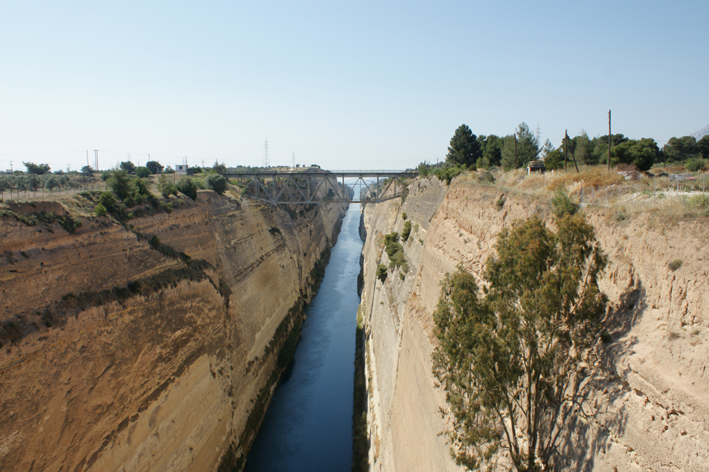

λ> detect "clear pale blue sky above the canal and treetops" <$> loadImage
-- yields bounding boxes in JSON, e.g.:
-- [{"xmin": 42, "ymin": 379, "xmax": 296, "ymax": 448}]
[{"xmin": 0, "ymin": 0, "xmax": 709, "ymax": 170}]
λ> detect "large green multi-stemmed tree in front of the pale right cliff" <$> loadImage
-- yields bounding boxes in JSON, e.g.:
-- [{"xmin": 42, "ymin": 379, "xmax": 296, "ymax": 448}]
[{"xmin": 433, "ymin": 214, "xmax": 607, "ymax": 471}]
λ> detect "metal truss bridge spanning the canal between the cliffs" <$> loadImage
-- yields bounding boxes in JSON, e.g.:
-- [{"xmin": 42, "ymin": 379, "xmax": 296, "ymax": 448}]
[{"xmin": 222, "ymin": 168, "xmax": 418, "ymax": 205}]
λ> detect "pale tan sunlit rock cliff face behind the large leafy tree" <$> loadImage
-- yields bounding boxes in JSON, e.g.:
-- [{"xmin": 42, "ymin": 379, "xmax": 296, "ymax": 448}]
[{"xmin": 361, "ymin": 178, "xmax": 709, "ymax": 471}]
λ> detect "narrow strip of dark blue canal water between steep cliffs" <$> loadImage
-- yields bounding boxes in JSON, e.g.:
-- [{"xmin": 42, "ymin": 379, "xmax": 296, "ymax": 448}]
[{"xmin": 246, "ymin": 204, "xmax": 362, "ymax": 472}]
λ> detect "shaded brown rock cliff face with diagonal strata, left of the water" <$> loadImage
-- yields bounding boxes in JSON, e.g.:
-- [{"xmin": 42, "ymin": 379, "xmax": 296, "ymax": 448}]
[{"xmin": 0, "ymin": 191, "xmax": 344, "ymax": 471}]
